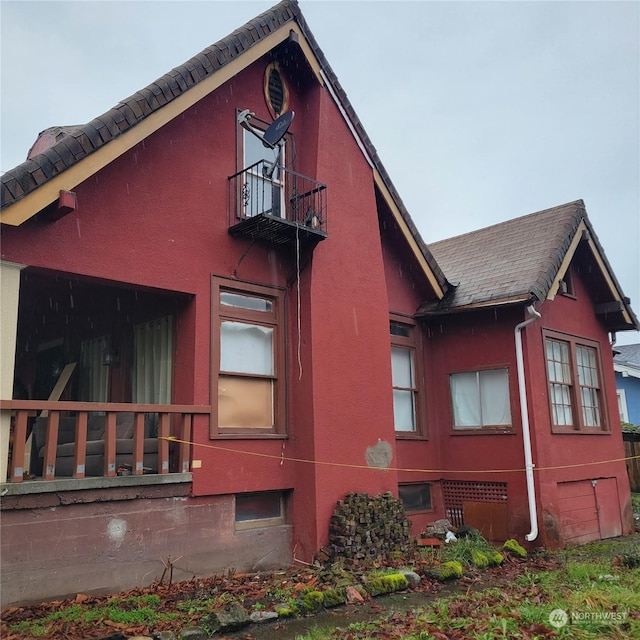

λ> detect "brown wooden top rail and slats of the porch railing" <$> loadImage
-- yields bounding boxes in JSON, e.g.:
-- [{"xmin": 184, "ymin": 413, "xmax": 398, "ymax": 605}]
[{"xmin": 0, "ymin": 400, "xmax": 211, "ymax": 482}]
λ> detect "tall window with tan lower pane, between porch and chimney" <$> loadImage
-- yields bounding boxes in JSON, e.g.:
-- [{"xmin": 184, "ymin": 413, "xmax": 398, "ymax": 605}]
[{"xmin": 211, "ymin": 278, "xmax": 285, "ymax": 436}]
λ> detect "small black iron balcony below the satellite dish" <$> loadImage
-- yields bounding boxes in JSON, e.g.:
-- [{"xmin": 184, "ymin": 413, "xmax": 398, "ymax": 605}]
[{"xmin": 229, "ymin": 160, "xmax": 328, "ymax": 246}]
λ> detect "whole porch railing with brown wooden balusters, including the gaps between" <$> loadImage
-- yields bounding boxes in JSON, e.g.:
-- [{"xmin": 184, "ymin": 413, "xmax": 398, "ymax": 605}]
[{"xmin": 0, "ymin": 400, "xmax": 211, "ymax": 482}]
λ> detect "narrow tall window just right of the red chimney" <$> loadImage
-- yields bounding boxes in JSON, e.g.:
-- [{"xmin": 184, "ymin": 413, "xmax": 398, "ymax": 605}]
[{"xmin": 390, "ymin": 319, "xmax": 424, "ymax": 437}]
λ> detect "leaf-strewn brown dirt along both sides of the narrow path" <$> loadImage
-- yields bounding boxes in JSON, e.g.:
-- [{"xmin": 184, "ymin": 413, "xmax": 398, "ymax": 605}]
[{"xmin": 0, "ymin": 533, "xmax": 640, "ymax": 640}]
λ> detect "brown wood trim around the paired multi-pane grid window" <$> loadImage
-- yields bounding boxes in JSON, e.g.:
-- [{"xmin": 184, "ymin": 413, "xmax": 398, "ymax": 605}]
[{"xmin": 542, "ymin": 329, "xmax": 611, "ymax": 435}]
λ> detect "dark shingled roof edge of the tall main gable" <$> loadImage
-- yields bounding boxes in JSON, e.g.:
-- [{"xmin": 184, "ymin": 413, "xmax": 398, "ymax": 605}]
[{"xmin": 1, "ymin": 0, "xmax": 449, "ymax": 292}]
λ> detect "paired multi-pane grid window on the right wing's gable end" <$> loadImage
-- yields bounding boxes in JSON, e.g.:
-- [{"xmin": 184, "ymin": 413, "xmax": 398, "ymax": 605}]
[{"xmin": 545, "ymin": 331, "xmax": 606, "ymax": 433}]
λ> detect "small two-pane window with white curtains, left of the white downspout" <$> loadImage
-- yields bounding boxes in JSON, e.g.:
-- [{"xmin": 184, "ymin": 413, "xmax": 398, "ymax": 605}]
[{"xmin": 449, "ymin": 369, "xmax": 511, "ymax": 430}]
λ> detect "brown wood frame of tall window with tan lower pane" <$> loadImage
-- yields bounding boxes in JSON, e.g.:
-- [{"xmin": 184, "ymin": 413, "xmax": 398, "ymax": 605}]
[{"xmin": 209, "ymin": 275, "xmax": 287, "ymax": 439}]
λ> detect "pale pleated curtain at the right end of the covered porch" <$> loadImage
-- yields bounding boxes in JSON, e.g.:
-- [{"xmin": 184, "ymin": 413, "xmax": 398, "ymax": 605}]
[{"xmin": 133, "ymin": 316, "xmax": 173, "ymax": 404}]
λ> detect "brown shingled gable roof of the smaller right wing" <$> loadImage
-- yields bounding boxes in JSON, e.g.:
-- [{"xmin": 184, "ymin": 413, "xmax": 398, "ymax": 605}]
[{"xmin": 418, "ymin": 200, "xmax": 639, "ymax": 330}]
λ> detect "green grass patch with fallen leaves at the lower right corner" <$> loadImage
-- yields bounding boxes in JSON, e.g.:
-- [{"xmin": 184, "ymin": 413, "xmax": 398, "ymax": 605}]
[{"xmin": 297, "ymin": 544, "xmax": 640, "ymax": 640}]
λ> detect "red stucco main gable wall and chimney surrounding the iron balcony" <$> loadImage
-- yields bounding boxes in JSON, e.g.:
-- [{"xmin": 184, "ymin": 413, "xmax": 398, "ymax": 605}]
[{"xmin": 2, "ymin": 58, "xmax": 404, "ymax": 560}]
